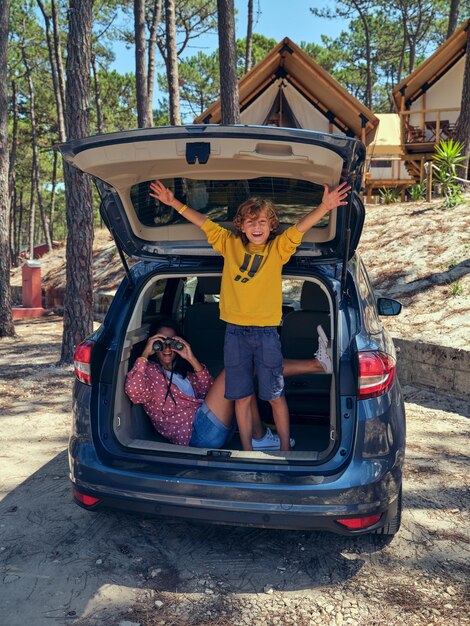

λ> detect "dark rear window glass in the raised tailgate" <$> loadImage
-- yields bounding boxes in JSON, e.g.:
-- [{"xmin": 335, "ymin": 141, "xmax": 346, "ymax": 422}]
[{"xmin": 131, "ymin": 176, "xmax": 329, "ymax": 228}]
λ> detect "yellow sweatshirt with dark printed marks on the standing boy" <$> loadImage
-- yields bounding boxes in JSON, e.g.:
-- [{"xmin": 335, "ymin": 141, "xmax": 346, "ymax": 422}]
[{"xmin": 202, "ymin": 219, "xmax": 303, "ymax": 326}]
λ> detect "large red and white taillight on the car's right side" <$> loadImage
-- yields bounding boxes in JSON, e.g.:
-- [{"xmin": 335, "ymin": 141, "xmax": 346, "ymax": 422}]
[{"xmin": 357, "ymin": 351, "xmax": 397, "ymax": 400}]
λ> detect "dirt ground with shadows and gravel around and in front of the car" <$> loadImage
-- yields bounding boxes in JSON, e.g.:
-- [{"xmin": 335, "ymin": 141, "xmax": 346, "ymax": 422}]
[{"xmin": 0, "ymin": 318, "xmax": 470, "ymax": 626}]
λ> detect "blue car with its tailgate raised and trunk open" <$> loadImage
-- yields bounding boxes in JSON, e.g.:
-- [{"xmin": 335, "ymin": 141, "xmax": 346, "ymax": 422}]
[{"xmin": 60, "ymin": 125, "xmax": 405, "ymax": 535}]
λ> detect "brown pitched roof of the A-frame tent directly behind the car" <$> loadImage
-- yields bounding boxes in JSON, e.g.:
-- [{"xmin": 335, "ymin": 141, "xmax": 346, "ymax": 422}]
[{"xmin": 195, "ymin": 37, "xmax": 378, "ymax": 143}]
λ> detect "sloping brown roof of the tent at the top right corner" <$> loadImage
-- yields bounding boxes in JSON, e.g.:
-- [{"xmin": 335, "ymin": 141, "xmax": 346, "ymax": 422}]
[{"xmin": 392, "ymin": 19, "xmax": 470, "ymax": 110}]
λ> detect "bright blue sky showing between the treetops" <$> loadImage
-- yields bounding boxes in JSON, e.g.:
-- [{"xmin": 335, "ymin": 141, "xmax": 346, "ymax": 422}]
[{"xmin": 112, "ymin": 0, "xmax": 346, "ymax": 79}]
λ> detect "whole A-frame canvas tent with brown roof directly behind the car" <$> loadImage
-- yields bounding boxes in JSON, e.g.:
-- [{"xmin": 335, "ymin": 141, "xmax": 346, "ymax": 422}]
[{"xmin": 195, "ymin": 37, "xmax": 379, "ymax": 145}]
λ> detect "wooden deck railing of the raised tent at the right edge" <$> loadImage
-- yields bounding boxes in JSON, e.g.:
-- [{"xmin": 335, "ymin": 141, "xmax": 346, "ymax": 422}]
[{"xmin": 400, "ymin": 107, "xmax": 460, "ymax": 144}]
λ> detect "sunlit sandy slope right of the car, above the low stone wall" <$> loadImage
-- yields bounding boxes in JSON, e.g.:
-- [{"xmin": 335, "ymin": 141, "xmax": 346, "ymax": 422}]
[{"xmin": 359, "ymin": 194, "xmax": 470, "ymax": 349}]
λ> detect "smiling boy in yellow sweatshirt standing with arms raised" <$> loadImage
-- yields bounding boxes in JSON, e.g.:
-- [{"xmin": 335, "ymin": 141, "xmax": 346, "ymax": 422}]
[{"xmin": 150, "ymin": 180, "xmax": 351, "ymax": 451}]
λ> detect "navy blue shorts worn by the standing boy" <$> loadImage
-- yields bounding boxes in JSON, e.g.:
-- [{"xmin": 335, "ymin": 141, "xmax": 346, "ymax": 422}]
[{"xmin": 224, "ymin": 324, "xmax": 284, "ymax": 401}]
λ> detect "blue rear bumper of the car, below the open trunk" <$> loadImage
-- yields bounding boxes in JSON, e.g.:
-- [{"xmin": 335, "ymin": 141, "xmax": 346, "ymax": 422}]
[{"xmin": 69, "ymin": 438, "xmax": 402, "ymax": 535}]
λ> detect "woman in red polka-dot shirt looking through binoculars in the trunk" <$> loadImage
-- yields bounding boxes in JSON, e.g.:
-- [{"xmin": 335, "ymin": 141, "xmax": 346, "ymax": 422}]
[{"xmin": 125, "ymin": 319, "xmax": 323, "ymax": 450}]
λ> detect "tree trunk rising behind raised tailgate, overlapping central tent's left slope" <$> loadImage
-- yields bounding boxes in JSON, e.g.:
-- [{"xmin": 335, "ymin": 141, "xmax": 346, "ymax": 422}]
[{"xmin": 217, "ymin": 0, "xmax": 240, "ymax": 124}]
